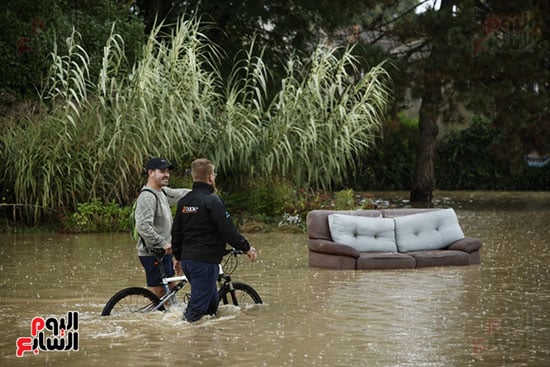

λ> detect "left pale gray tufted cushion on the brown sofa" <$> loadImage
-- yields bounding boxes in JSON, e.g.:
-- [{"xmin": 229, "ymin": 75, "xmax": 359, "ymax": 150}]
[{"xmin": 328, "ymin": 214, "xmax": 397, "ymax": 252}]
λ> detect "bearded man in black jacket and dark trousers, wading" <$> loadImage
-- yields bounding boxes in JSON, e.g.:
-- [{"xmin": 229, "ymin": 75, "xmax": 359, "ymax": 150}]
[{"xmin": 172, "ymin": 158, "xmax": 257, "ymax": 322}]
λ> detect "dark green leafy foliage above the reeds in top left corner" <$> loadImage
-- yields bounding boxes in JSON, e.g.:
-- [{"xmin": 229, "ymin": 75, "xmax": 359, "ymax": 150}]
[{"xmin": 0, "ymin": 0, "xmax": 143, "ymax": 107}]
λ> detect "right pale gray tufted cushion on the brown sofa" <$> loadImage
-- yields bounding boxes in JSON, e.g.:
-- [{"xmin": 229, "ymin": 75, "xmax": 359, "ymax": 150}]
[{"xmin": 394, "ymin": 209, "xmax": 464, "ymax": 252}]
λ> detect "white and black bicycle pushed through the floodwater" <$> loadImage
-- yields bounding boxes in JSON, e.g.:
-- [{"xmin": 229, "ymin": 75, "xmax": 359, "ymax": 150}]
[{"xmin": 101, "ymin": 249, "xmax": 263, "ymax": 316}]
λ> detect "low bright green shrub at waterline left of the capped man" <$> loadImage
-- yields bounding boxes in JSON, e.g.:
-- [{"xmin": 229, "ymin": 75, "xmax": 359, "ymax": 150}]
[{"xmin": 62, "ymin": 199, "xmax": 132, "ymax": 233}]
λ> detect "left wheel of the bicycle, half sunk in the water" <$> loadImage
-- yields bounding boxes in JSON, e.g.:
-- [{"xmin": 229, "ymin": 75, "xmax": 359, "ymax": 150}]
[{"xmin": 101, "ymin": 287, "xmax": 164, "ymax": 316}]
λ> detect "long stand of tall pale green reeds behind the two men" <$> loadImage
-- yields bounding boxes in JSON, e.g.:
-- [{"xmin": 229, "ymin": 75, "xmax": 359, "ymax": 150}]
[{"xmin": 0, "ymin": 20, "xmax": 389, "ymax": 227}]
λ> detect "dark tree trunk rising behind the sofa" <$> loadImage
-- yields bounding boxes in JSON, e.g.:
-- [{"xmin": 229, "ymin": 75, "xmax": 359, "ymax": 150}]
[{"xmin": 410, "ymin": 75, "xmax": 441, "ymax": 207}]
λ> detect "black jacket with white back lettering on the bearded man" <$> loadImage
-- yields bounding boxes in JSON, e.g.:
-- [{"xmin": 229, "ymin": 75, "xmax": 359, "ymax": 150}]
[{"xmin": 172, "ymin": 182, "xmax": 250, "ymax": 264}]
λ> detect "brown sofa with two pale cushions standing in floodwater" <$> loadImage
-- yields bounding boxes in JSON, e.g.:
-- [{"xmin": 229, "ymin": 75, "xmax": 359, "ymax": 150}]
[{"xmin": 307, "ymin": 208, "xmax": 482, "ymax": 269}]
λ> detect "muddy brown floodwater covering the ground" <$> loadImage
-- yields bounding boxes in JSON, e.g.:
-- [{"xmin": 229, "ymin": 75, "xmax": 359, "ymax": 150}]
[{"xmin": 0, "ymin": 192, "xmax": 550, "ymax": 367}]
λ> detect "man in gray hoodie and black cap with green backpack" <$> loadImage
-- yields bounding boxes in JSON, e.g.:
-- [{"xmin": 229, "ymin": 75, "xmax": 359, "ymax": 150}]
[{"xmin": 134, "ymin": 158, "xmax": 191, "ymax": 297}]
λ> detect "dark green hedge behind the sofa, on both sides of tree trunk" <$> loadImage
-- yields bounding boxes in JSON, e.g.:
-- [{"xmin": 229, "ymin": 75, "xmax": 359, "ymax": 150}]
[{"xmin": 346, "ymin": 116, "xmax": 550, "ymax": 191}]
